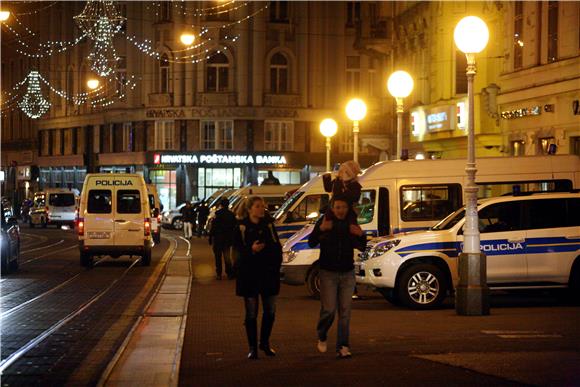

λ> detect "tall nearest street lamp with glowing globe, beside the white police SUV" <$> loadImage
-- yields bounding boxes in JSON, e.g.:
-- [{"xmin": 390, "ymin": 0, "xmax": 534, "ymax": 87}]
[{"xmin": 453, "ymin": 16, "xmax": 489, "ymax": 316}]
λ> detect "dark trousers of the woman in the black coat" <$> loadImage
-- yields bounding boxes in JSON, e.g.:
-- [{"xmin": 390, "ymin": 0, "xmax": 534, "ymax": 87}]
[{"xmin": 244, "ymin": 296, "xmax": 276, "ymax": 349}]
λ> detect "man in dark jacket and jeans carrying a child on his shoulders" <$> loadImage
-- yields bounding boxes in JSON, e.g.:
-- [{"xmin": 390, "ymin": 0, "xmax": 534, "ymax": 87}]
[{"xmin": 308, "ymin": 196, "xmax": 366, "ymax": 358}]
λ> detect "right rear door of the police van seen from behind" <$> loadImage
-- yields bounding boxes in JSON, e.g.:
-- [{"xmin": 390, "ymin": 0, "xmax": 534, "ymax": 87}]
[{"xmin": 115, "ymin": 186, "xmax": 144, "ymax": 246}]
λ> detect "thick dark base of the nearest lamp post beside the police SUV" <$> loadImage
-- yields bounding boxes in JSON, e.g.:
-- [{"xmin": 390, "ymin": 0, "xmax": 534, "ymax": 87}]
[{"xmin": 455, "ymin": 253, "xmax": 489, "ymax": 316}]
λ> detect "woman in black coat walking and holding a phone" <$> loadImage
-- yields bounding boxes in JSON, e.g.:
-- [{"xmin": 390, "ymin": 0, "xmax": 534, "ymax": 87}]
[{"xmin": 234, "ymin": 196, "xmax": 282, "ymax": 359}]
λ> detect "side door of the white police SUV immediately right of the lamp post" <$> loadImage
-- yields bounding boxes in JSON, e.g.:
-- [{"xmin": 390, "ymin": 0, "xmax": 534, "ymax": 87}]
[{"xmin": 478, "ymin": 201, "xmax": 528, "ymax": 283}]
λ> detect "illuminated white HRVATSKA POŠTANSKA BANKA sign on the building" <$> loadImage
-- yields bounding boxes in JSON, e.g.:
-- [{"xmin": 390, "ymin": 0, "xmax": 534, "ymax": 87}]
[{"xmin": 153, "ymin": 153, "xmax": 286, "ymax": 165}]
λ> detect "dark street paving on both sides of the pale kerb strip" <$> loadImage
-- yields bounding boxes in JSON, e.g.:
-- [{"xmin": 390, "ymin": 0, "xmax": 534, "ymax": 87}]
[{"xmin": 1, "ymin": 226, "xmax": 580, "ymax": 386}]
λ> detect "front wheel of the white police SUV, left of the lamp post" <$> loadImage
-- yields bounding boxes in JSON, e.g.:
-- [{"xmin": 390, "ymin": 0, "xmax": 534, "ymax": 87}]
[{"xmin": 397, "ymin": 264, "xmax": 447, "ymax": 309}]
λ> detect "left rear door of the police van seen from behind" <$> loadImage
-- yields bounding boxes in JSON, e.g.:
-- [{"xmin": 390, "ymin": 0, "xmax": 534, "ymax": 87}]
[{"xmin": 81, "ymin": 188, "xmax": 114, "ymax": 246}]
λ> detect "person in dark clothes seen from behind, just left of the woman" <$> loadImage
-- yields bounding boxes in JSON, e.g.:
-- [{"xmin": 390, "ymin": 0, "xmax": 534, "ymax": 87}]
[{"xmin": 209, "ymin": 198, "xmax": 237, "ymax": 280}]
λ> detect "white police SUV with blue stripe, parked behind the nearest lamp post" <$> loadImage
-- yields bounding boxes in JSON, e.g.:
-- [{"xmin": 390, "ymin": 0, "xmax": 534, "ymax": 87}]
[{"xmin": 355, "ymin": 192, "xmax": 580, "ymax": 309}]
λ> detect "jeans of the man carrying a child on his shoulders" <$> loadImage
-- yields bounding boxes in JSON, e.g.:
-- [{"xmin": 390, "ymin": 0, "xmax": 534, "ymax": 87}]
[{"xmin": 316, "ymin": 269, "xmax": 355, "ymax": 351}]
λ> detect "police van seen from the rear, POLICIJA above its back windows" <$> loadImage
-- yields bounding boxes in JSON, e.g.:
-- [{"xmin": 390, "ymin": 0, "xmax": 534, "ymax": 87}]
[{"xmin": 77, "ymin": 173, "xmax": 151, "ymax": 267}]
